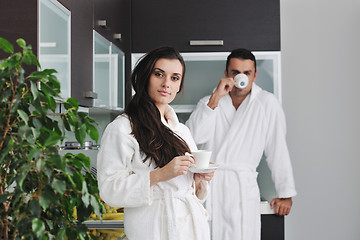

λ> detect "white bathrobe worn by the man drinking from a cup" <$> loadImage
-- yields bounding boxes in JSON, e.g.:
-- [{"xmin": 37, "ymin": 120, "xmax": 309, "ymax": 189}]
[{"xmin": 186, "ymin": 84, "xmax": 296, "ymax": 240}]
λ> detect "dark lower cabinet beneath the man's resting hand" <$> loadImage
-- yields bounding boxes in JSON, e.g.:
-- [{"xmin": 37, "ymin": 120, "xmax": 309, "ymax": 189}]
[{"xmin": 261, "ymin": 214, "xmax": 285, "ymax": 240}]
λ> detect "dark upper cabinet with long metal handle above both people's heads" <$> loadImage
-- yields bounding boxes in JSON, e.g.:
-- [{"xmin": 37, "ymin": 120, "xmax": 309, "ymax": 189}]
[{"xmin": 132, "ymin": 0, "xmax": 280, "ymax": 53}]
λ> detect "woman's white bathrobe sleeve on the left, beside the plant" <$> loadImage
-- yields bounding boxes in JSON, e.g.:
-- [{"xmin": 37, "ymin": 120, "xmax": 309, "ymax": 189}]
[{"xmin": 97, "ymin": 117, "xmax": 152, "ymax": 207}]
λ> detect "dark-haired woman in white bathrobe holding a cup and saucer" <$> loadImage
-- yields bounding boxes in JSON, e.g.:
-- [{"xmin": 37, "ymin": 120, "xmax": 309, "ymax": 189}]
[{"xmin": 97, "ymin": 47, "xmax": 214, "ymax": 240}]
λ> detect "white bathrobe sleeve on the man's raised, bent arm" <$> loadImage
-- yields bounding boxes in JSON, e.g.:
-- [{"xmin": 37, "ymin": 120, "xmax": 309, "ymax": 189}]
[{"xmin": 186, "ymin": 96, "xmax": 218, "ymax": 144}]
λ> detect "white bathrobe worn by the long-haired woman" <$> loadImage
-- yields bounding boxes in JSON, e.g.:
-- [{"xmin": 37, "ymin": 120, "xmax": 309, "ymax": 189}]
[{"xmin": 97, "ymin": 107, "xmax": 210, "ymax": 240}]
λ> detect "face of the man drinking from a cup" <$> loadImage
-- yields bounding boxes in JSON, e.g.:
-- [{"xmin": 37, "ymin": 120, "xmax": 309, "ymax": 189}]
[{"xmin": 224, "ymin": 58, "xmax": 257, "ymax": 97}]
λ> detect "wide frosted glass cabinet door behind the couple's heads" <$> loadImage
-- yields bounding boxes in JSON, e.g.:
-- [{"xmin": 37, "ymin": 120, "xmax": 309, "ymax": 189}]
[{"xmin": 132, "ymin": 52, "xmax": 281, "ymax": 113}]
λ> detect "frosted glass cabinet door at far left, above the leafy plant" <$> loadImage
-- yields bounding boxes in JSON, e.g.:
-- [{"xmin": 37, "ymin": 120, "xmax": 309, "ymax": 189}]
[{"xmin": 39, "ymin": 0, "xmax": 71, "ymax": 98}]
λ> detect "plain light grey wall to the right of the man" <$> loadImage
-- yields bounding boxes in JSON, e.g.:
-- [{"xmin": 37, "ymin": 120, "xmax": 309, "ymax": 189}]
[{"xmin": 280, "ymin": 0, "xmax": 360, "ymax": 240}]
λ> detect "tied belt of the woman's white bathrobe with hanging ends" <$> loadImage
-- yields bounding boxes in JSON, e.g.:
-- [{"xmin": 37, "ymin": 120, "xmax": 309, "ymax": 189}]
[{"xmin": 153, "ymin": 188, "xmax": 206, "ymax": 240}]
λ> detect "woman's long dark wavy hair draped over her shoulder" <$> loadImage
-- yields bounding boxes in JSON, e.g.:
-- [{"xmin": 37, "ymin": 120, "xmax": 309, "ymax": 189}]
[{"xmin": 125, "ymin": 47, "xmax": 190, "ymax": 167}]
